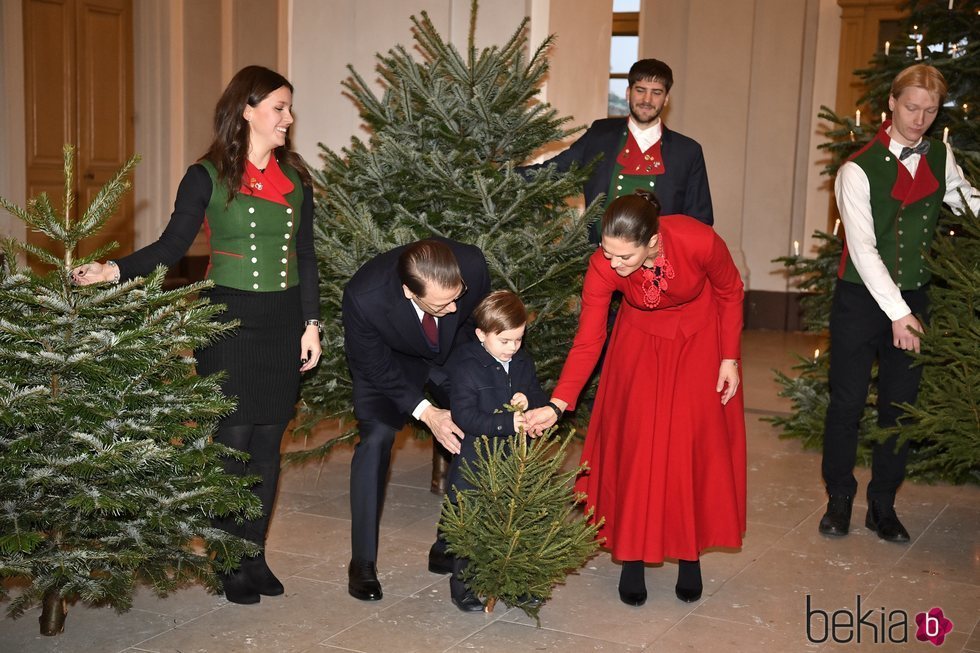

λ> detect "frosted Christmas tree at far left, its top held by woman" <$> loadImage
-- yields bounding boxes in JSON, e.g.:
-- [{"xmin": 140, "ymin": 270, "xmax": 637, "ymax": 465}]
[{"xmin": 0, "ymin": 147, "xmax": 260, "ymax": 635}]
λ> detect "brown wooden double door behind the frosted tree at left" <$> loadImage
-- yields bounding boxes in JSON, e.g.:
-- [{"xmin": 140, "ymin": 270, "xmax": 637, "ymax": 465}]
[{"xmin": 24, "ymin": 0, "xmax": 134, "ymax": 268}]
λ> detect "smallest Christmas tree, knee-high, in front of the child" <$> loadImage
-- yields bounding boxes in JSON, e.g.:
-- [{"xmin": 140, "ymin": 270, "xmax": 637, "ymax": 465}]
[{"xmin": 439, "ymin": 420, "xmax": 599, "ymax": 625}]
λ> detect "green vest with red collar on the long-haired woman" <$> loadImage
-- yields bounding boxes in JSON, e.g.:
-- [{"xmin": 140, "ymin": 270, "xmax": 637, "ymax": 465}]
[{"xmin": 201, "ymin": 160, "xmax": 303, "ymax": 292}]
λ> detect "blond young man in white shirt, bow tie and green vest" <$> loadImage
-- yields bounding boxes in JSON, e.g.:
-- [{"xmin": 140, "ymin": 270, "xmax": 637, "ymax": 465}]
[{"xmin": 819, "ymin": 64, "xmax": 980, "ymax": 542}]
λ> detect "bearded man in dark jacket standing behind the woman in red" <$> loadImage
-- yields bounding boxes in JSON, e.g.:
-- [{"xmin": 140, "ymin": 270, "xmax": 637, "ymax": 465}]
[{"xmin": 523, "ymin": 59, "xmax": 714, "ymax": 239}]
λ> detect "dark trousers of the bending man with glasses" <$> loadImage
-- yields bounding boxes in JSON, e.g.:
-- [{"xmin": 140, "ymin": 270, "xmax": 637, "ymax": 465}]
[{"xmin": 350, "ymin": 383, "xmax": 449, "ymax": 562}]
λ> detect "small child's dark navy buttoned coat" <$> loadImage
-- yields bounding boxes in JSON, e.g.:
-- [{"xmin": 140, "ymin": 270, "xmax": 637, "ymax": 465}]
[{"xmin": 449, "ymin": 341, "xmax": 548, "ymax": 441}]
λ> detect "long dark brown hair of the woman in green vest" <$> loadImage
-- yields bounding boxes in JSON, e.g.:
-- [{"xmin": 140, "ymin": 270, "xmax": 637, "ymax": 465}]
[{"xmin": 201, "ymin": 66, "xmax": 313, "ymax": 202}]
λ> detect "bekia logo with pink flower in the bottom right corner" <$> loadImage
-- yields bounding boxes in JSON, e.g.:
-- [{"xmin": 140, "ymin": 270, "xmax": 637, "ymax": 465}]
[{"xmin": 806, "ymin": 594, "xmax": 953, "ymax": 646}]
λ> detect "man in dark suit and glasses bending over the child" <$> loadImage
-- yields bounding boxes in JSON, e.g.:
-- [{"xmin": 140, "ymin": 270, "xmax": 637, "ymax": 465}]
[{"xmin": 343, "ymin": 238, "xmax": 490, "ymax": 601}]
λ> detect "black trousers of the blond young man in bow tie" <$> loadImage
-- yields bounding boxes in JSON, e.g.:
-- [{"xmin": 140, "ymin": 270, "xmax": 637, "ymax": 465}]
[{"xmin": 822, "ymin": 280, "xmax": 929, "ymax": 505}]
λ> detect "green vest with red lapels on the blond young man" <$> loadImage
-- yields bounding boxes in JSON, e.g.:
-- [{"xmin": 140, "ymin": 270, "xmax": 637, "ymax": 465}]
[{"xmin": 838, "ymin": 130, "xmax": 946, "ymax": 290}]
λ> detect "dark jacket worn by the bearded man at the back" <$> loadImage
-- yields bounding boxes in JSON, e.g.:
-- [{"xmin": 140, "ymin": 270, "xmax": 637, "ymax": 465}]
[{"xmin": 525, "ymin": 118, "xmax": 715, "ymax": 243}]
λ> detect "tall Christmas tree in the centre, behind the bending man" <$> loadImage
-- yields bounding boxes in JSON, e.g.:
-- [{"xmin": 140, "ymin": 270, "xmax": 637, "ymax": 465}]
[{"xmin": 290, "ymin": 2, "xmax": 599, "ymax": 457}]
